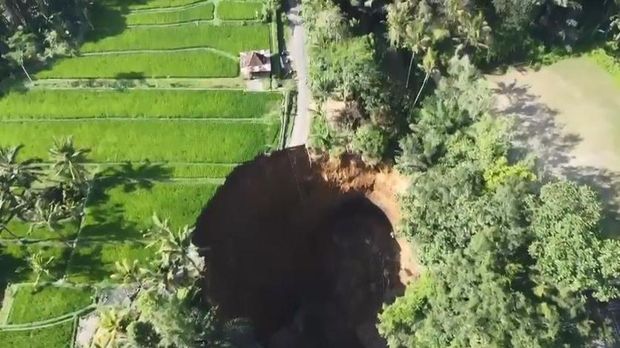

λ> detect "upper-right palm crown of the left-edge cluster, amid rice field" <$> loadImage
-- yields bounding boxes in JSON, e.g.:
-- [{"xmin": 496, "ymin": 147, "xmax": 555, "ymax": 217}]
[{"xmin": 49, "ymin": 137, "xmax": 90, "ymax": 187}]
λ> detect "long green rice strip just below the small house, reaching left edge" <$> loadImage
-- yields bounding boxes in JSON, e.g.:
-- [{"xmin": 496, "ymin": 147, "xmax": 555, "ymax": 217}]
[{"xmin": 0, "ymin": 89, "xmax": 282, "ymax": 120}]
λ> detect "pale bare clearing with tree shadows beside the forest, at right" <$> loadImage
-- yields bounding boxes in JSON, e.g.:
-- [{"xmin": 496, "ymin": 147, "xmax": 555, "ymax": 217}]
[{"xmin": 488, "ymin": 57, "xmax": 620, "ymax": 232}]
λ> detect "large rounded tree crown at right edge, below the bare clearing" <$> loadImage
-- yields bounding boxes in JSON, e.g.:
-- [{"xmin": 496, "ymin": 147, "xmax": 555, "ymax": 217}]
[{"xmin": 529, "ymin": 182, "xmax": 620, "ymax": 301}]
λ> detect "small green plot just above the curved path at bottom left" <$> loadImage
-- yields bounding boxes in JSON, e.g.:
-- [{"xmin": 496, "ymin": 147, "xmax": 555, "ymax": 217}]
[{"xmin": 7, "ymin": 285, "xmax": 93, "ymax": 324}]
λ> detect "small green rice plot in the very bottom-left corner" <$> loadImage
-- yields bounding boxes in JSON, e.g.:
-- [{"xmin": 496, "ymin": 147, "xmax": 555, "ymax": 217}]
[{"xmin": 0, "ymin": 321, "xmax": 73, "ymax": 348}]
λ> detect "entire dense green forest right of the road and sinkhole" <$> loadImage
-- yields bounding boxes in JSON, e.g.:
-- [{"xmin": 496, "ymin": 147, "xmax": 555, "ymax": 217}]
[{"xmin": 303, "ymin": 0, "xmax": 620, "ymax": 347}]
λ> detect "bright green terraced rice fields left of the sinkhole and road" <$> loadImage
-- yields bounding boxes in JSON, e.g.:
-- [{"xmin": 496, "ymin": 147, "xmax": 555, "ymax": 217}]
[{"xmin": 0, "ymin": 0, "xmax": 286, "ymax": 348}]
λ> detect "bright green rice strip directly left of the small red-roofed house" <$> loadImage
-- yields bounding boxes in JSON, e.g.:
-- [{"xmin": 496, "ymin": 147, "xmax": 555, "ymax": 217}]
[{"xmin": 36, "ymin": 50, "xmax": 239, "ymax": 79}]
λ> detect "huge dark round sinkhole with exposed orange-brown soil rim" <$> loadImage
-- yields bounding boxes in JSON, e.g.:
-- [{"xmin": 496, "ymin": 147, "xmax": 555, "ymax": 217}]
[{"xmin": 194, "ymin": 147, "xmax": 418, "ymax": 348}]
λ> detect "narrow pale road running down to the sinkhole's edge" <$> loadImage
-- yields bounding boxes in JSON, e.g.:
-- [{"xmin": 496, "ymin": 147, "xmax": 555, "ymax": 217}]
[{"xmin": 287, "ymin": 0, "xmax": 312, "ymax": 147}]
